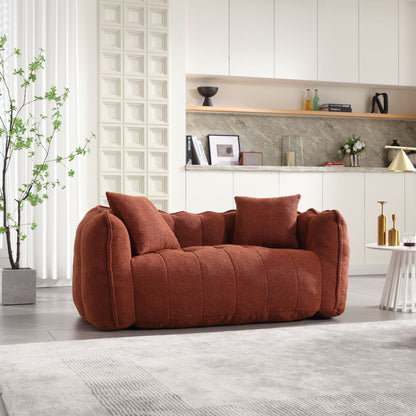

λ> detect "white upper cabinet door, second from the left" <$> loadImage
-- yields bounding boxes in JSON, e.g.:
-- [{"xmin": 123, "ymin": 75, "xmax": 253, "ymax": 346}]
[{"xmin": 230, "ymin": 0, "xmax": 274, "ymax": 78}]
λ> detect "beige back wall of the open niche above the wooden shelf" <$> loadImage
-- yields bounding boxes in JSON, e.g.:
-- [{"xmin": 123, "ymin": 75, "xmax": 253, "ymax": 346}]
[{"xmin": 186, "ymin": 75, "xmax": 416, "ymax": 114}]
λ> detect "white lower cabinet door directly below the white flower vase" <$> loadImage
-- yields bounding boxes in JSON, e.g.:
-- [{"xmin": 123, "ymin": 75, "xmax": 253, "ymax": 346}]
[{"xmin": 323, "ymin": 172, "xmax": 364, "ymax": 265}]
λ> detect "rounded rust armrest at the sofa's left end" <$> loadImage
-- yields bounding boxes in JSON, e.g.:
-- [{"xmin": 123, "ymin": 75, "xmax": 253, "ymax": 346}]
[{"xmin": 72, "ymin": 207, "xmax": 135, "ymax": 329}]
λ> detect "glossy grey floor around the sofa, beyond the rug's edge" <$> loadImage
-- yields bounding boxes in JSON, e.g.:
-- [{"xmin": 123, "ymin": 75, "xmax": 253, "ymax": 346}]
[{"xmin": 0, "ymin": 276, "xmax": 416, "ymax": 344}]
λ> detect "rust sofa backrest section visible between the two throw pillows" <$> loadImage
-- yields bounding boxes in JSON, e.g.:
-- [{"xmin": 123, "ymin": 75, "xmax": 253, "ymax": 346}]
[{"xmin": 159, "ymin": 210, "xmax": 235, "ymax": 248}]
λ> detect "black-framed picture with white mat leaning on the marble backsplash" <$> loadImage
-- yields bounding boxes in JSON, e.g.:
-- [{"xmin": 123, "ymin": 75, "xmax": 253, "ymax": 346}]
[{"xmin": 207, "ymin": 134, "xmax": 240, "ymax": 165}]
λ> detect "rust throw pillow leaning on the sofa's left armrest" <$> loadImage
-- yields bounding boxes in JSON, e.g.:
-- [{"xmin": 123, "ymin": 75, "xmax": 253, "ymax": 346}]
[{"xmin": 106, "ymin": 192, "xmax": 180, "ymax": 254}]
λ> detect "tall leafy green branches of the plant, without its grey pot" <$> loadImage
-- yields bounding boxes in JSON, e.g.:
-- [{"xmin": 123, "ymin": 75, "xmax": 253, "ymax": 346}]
[{"xmin": 0, "ymin": 35, "xmax": 95, "ymax": 269}]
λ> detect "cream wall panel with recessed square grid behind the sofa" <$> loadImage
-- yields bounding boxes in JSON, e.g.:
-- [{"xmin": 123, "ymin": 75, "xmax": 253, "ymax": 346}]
[{"xmin": 98, "ymin": 0, "xmax": 169, "ymax": 210}]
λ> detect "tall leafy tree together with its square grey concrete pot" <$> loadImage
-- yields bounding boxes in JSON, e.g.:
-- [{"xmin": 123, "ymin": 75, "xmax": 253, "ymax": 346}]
[{"xmin": 0, "ymin": 35, "xmax": 94, "ymax": 305}]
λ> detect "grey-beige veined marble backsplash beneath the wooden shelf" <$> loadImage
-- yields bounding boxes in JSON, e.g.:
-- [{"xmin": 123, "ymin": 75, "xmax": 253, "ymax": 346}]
[{"xmin": 186, "ymin": 111, "xmax": 416, "ymax": 167}]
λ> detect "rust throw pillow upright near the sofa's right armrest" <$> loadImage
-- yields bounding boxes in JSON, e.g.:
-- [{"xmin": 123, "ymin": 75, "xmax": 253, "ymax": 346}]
[{"xmin": 233, "ymin": 194, "xmax": 300, "ymax": 248}]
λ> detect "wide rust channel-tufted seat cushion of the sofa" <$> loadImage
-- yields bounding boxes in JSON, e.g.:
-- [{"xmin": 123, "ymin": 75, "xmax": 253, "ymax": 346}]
[{"xmin": 131, "ymin": 245, "xmax": 322, "ymax": 328}]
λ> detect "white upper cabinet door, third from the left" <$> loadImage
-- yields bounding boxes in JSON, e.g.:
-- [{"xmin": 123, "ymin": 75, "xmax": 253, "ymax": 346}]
[{"xmin": 275, "ymin": 0, "xmax": 318, "ymax": 80}]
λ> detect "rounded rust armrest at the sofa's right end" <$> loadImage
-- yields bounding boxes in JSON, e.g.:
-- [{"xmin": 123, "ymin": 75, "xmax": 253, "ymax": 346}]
[{"xmin": 297, "ymin": 209, "xmax": 350, "ymax": 318}]
